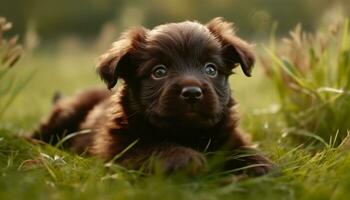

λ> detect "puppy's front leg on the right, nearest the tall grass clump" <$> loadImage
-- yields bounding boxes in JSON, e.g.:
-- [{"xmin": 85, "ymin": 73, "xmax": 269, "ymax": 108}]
[{"xmin": 225, "ymin": 129, "xmax": 275, "ymax": 176}]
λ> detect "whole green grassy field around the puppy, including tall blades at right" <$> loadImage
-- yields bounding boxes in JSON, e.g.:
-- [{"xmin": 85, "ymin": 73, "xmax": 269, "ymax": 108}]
[{"xmin": 0, "ymin": 18, "xmax": 350, "ymax": 200}]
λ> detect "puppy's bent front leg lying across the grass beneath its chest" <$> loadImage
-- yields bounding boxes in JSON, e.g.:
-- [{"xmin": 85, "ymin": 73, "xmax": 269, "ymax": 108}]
[{"xmin": 119, "ymin": 144, "xmax": 206, "ymax": 175}]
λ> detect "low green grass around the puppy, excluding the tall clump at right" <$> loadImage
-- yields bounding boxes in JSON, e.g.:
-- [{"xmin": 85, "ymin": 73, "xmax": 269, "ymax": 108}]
[{"xmin": 0, "ymin": 18, "xmax": 350, "ymax": 200}]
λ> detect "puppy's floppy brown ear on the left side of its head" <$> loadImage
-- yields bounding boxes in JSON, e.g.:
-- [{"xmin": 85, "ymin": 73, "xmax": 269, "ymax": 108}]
[{"xmin": 96, "ymin": 27, "xmax": 147, "ymax": 89}]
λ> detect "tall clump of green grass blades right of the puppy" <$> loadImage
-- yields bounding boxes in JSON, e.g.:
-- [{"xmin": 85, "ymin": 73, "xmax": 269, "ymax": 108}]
[{"xmin": 261, "ymin": 19, "xmax": 350, "ymax": 145}]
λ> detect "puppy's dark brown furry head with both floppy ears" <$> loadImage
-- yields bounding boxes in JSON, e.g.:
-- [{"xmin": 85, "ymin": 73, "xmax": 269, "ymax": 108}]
[{"xmin": 97, "ymin": 18, "xmax": 254, "ymax": 128}]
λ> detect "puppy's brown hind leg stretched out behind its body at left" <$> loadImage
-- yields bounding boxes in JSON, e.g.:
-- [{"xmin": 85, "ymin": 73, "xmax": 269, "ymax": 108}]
[{"xmin": 31, "ymin": 89, "xmax": 110, "ymax": 144}]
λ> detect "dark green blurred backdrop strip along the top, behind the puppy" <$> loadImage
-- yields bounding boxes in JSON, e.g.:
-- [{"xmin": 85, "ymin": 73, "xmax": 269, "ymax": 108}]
[{"xmin": 0, "ymin": 0, "xmax": 350, "ymax": 44}]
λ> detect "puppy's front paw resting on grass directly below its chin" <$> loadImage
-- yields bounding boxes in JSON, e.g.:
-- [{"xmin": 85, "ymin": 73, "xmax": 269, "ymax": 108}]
[{"xmin": 160, "ymin": 147, "xmax": 206, "ymax": 175}]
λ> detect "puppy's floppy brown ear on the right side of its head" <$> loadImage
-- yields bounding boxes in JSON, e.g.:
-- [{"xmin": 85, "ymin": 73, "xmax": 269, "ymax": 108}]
[{"xmin": 206, "ymin": 17, "xmax": 255, "ymax": 76}]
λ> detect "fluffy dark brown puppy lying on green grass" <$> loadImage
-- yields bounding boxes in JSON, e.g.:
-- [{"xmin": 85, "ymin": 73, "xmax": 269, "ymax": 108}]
[{"xmin": 33, "ymin": 18, "xmax": 272, "ymax": 175}]
